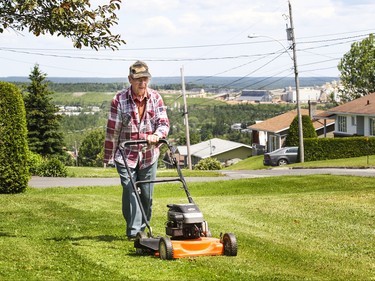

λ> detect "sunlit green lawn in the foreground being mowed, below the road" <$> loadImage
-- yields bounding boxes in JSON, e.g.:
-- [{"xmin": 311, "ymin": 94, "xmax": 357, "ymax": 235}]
[{"xmin": 0, "ymin": 175, "xmax": 375, "ymax": 280}]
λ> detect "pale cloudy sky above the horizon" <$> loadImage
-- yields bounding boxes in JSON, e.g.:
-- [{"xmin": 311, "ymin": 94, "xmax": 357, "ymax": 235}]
[{"xmin": 0, "ymin": 0, "xmax": 375, "ymax": 79}]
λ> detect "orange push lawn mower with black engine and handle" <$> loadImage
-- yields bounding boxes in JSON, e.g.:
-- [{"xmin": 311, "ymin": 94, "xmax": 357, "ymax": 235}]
[{"xmin": 119, "ymin": 139, "xmax": 237, "ymax": 260}]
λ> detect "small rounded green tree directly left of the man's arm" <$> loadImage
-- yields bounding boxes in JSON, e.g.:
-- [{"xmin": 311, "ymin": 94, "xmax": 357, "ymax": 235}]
[{"xmin": 78, "ymin": 129, "xmax": 105, "ymax": 167}]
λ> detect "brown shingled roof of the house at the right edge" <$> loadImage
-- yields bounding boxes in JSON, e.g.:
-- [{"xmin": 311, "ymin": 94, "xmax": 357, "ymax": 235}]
[{"xmin": 315, "ymin": 93, "xmax": 375, "ymax": 118}]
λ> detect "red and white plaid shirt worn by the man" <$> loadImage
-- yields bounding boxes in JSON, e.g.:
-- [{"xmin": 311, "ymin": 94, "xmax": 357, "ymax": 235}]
[{"xmin": 104, "ymin": 87, "xmax": 169, "ymax": 169}]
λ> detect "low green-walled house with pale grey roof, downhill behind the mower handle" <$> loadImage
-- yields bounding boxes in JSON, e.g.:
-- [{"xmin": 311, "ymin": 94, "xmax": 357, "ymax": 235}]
[{"xmin": 164, "ymin": 138, "xmax": 252, "ymax": 167}]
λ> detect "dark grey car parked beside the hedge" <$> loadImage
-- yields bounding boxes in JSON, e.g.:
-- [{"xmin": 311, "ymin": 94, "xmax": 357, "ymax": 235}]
[{"xmin": 263, "ymin": 146, "xmax": 298, "ymax": 166}]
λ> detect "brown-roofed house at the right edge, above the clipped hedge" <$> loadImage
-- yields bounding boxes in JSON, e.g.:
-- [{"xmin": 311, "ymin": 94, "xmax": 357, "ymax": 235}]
[{"xmin": 314, "ymin": 93, "xmax": 375, "ymax": 137}]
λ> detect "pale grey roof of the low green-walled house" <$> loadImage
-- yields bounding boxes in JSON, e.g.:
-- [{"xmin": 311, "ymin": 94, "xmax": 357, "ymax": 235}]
[{"xmin": 177, "ymin": 138, "xmax": 252, "ymax": 159}]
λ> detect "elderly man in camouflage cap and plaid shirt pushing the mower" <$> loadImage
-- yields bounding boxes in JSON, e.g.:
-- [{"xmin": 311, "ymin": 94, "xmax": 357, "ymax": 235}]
[{"xmin": 104, "ymin": 61, "xmax": 169, "ymax": 240}]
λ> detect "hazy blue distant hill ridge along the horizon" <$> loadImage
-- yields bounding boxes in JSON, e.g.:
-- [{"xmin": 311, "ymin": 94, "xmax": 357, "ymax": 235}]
[{"xmin": 0, "ymin": 76, "xmax": 339, "ymax": 89}]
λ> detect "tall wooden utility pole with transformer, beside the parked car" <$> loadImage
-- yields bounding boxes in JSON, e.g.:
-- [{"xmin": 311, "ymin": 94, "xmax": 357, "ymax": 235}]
[{"xmin": 286, "ymin": 1, "xmax": 305, "ymax": 163}]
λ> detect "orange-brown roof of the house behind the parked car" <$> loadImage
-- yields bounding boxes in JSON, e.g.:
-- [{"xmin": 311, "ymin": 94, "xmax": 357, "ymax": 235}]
[{"xmin": 248, "ymin": 109, "xmax": 335, "ymax": 133}]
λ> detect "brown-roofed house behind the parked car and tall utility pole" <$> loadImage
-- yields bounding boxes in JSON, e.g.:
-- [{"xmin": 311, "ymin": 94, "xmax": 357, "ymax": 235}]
[{"xmin": 248, "ymin": 103, "xmax": 335, "ymax": 152}]
